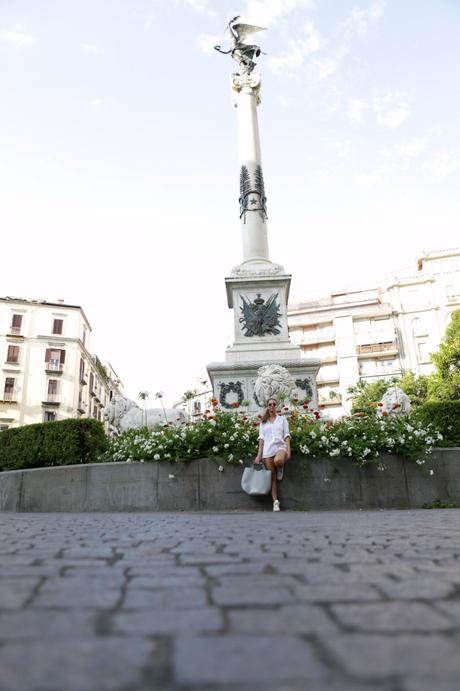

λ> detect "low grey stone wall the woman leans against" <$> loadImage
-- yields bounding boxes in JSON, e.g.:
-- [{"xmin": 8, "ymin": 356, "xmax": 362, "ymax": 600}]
[{"xmin": 0, "ymin": 448, "xmax": 460, "ymax": 512}]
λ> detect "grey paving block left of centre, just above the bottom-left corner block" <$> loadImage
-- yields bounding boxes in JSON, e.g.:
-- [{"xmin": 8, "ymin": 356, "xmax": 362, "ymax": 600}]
[{"xmin": 113, "ymin": 606, "xmax": 223, "ymax": 636}]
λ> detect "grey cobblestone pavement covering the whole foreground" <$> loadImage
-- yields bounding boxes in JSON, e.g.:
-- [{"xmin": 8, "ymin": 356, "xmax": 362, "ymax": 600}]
[{"xmin": 0, "ymin": 510, "xmax": 460, "ymax": 691}]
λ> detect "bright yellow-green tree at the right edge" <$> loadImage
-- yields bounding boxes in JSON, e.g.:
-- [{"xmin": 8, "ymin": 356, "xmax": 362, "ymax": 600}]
[{"xmin": 429, "ymin": 310, "xmax": 460, "ymax": 401}]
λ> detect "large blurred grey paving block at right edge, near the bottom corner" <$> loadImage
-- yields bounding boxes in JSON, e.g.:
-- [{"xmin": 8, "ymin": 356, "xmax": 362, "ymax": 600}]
[{"xmin": 323, "ymin": 633, "xmax": 460, "ymax": 680}]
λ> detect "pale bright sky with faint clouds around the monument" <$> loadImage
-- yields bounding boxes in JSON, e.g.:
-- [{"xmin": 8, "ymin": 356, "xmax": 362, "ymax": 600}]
[{"xmin": 0, "ymin": 0, "xmax": 460, "ymax": 406}]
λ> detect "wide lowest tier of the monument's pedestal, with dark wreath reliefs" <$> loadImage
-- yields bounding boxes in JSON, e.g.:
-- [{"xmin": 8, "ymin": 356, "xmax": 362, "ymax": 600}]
[{"xmin": 207, "ymin": 359, "xmax": 321, "ymax": 415}]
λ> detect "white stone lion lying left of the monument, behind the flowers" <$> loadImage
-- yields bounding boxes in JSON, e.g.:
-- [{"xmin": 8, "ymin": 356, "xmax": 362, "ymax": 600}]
[{"xmin": 103, "ymin": 395, "xmax": 187, "ymax": 432}]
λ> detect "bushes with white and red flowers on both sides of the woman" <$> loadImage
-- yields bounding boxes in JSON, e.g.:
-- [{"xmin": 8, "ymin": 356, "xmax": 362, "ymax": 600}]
[{"xmin": 107, "ymin": 409, "xmax": 439, "ymax": 464}]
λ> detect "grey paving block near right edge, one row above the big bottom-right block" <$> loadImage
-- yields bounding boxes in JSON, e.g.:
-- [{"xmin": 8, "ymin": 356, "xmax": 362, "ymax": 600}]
[{"xmin": 332, "ymin": 602, "xmax": 452, "ymax": 632}]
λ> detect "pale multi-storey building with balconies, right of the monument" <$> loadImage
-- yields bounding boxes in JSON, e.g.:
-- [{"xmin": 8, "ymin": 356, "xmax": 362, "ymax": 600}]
[{"xmin": 288, "ymin": 249, "xmax": 460, "ymax": 417}]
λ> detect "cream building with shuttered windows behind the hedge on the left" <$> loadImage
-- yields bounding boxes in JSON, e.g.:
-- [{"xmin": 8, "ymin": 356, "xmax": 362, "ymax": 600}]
[{"xmin": 0, "ymin": 297, "xmax": 122, "ymax": 430}]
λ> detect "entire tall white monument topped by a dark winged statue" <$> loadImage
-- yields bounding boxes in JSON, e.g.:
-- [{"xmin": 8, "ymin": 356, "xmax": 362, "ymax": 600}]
[{"xmin": 207, "ymin": 17, "xmax": 320, "ymax": 413}]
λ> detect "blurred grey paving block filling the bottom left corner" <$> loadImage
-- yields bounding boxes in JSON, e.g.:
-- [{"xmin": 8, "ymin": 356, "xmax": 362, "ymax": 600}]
[{"xmin": 0, "ymin": 637, "xmax": 154, "ymax": 691}]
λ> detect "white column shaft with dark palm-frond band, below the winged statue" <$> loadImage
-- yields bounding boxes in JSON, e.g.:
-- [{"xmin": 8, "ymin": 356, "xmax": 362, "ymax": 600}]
[{"xmin": 232, "ymin": 73, "xmax": 271, "ymax": 269}]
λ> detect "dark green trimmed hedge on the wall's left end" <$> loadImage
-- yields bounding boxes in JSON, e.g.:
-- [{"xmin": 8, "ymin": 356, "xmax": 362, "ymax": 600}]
[{"xmin": 0, "ymin": 419, "xmax": 107, "ymax": 471}]
